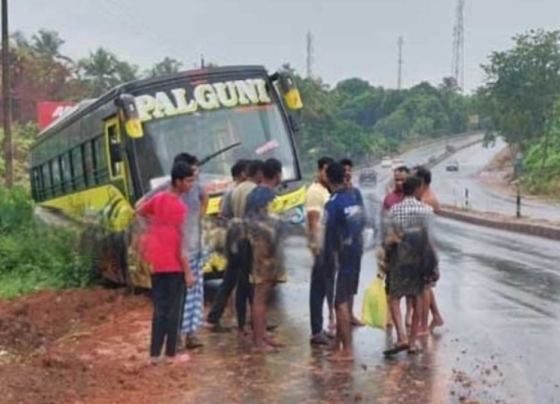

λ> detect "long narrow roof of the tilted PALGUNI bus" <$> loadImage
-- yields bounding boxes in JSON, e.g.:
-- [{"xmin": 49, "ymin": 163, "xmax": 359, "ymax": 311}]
[{"xmin": 31, "ymin": 65, "xmax": 266, "ymax": 148}]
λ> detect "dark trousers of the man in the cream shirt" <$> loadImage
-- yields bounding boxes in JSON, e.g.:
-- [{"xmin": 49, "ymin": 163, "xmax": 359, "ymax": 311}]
[{"xmin": 309, "ymin": 258, "xmax": 334, "ymax": 335}]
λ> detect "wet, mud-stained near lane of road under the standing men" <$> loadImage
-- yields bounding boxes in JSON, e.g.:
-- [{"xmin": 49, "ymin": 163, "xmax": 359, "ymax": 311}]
[{"xmin": 178, "ymin": 137, "xmax": 560, "ymax": 404}]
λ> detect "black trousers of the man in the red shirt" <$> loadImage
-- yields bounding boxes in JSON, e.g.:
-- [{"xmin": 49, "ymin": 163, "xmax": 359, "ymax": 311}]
[{"xmin": 150, "ymin": 272, "xmax": 185, "ymax": 357}]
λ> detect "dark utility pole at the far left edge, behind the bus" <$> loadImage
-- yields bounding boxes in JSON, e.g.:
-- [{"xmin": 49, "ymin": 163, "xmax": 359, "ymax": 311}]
[{"xmin": 2, "ymin": 0, "xmax": 14, "ymax": 188}]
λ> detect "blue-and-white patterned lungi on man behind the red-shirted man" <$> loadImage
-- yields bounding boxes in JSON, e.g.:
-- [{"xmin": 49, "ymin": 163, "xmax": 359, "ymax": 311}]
[{"xmin": 181, "ymin": 253, "xmax": 204, "ymax": 334}]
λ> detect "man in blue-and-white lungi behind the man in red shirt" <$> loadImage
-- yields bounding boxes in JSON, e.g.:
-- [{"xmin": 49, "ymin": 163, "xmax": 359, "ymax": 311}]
[{"xmin": 139, "ymin": 153, "xmax": 208, "ymax": 349}]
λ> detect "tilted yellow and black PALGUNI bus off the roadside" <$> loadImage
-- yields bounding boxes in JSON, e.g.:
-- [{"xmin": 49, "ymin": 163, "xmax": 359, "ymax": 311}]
[{"xmin": 30, "ymin": 66, "xmax": 305, "ymax": 287}]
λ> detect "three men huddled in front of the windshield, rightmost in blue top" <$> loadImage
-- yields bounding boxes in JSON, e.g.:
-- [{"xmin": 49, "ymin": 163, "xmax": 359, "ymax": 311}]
[{"xmin": 206, "ymin": 158, "xmax": 287, "ymax": 352}]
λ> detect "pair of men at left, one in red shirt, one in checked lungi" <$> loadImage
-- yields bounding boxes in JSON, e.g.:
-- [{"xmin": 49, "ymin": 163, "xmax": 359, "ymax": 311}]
[{"xmin": 136, "ymin": 153, "xmax": 208, "ymax": 364}]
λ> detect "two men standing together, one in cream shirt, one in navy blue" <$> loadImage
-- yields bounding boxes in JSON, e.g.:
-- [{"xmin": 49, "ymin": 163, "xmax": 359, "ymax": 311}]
[{"xmin": 305, "ymin": 157, "xmax": 366, "ymax": 360}]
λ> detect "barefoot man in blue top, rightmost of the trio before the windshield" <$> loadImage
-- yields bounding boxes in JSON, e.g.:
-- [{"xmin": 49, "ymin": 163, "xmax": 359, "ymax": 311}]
[{"xmin": 245, "ymin": 158, "xmax": 286, "ymax": 352}]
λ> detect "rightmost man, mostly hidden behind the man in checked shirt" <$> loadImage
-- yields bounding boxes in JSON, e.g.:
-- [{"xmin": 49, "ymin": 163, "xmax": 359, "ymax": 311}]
[{"xmin": 415, "ymin": 167, "xmax": 444, "ymax": 335}]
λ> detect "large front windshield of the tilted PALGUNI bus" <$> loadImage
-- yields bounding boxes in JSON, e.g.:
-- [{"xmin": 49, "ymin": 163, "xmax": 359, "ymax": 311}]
[{"xmin": 136, "ymin": 103, "xmax": 298, "ymax": 193}]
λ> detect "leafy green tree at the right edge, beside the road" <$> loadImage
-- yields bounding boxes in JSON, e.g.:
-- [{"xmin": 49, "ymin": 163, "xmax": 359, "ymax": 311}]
[{"xmin": 481, "ymin": 30, "xmax": 560, "ymax": 168}]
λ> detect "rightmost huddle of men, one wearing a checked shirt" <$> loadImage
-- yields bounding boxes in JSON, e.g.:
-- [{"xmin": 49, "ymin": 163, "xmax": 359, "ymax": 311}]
[{"xmin": 378, "ymin": 166, "xmax": 443, "ymax": 355}]
